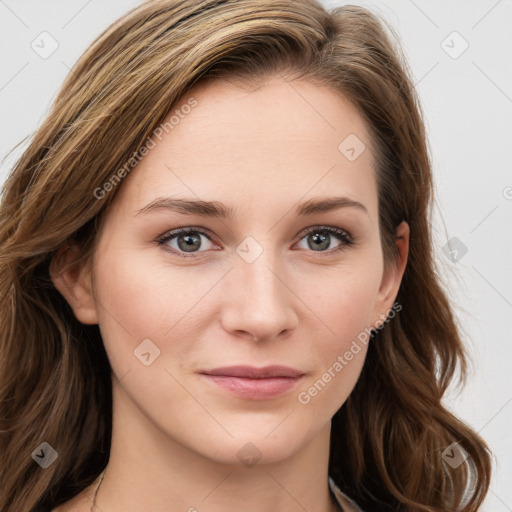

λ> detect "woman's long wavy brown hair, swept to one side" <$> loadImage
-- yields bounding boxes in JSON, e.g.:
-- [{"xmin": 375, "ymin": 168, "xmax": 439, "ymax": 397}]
[{"xmin": 0, "ymin": 0, "xmax": 491, "ymax": 512}]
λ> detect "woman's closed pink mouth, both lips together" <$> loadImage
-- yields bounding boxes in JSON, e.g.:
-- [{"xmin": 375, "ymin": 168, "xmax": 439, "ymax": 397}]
[{"xmin": 199, "ymin": 366, "xmax": 305, "ymax": 400}]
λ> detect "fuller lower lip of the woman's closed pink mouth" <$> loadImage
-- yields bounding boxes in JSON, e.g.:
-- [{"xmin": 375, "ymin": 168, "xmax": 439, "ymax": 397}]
[{"xmin": 203, "ymin": 374, "xmax": 302, "ymax": 400}]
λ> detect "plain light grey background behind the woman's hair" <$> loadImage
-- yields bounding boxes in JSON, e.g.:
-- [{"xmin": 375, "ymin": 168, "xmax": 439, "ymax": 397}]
[{"xmin": 0, "ymin": 0, "xmax": 512, "ymax": 512}]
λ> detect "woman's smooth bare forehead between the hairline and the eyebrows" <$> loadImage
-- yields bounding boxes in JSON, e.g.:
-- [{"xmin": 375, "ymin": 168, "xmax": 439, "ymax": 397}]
[{"xmin": 113, "ymin": 78, "xmax": 376, "ymax": 217}]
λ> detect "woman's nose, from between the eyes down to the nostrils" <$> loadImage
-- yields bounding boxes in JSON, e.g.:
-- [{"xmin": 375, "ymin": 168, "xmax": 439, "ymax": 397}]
[{"xmin": 221, "ymin": 246, "xmax": 299, "ymax": 341}]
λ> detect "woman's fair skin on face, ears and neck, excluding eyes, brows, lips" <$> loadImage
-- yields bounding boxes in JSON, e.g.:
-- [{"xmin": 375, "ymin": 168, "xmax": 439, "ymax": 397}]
[{"xmin": 52, "ymin": 77, "xmax": 409, "ymax": 512}]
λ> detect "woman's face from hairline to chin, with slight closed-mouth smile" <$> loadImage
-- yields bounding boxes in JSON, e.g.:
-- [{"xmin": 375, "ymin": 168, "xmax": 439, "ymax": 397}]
[{"xmin": 59, "ymin": 78, "xmax": 407, "ymax": 463}]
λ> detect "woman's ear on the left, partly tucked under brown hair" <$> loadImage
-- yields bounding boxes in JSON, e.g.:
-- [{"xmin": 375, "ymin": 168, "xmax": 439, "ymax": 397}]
[{"xmin": 50, "ymin": 244, "xmax": 98, "ymax": 324}]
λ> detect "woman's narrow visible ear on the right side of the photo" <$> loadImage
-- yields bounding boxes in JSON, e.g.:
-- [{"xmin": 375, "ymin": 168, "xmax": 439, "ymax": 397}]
[{"xmin": 372, "ymin": 221, "xmax": 410, "ymax": 329}]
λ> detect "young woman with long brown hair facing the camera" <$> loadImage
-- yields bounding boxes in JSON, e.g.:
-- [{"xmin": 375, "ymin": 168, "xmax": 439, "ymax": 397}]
[{"xmin": 0, "ymin": 0, "xmax": 490, "ymax": 512}]
